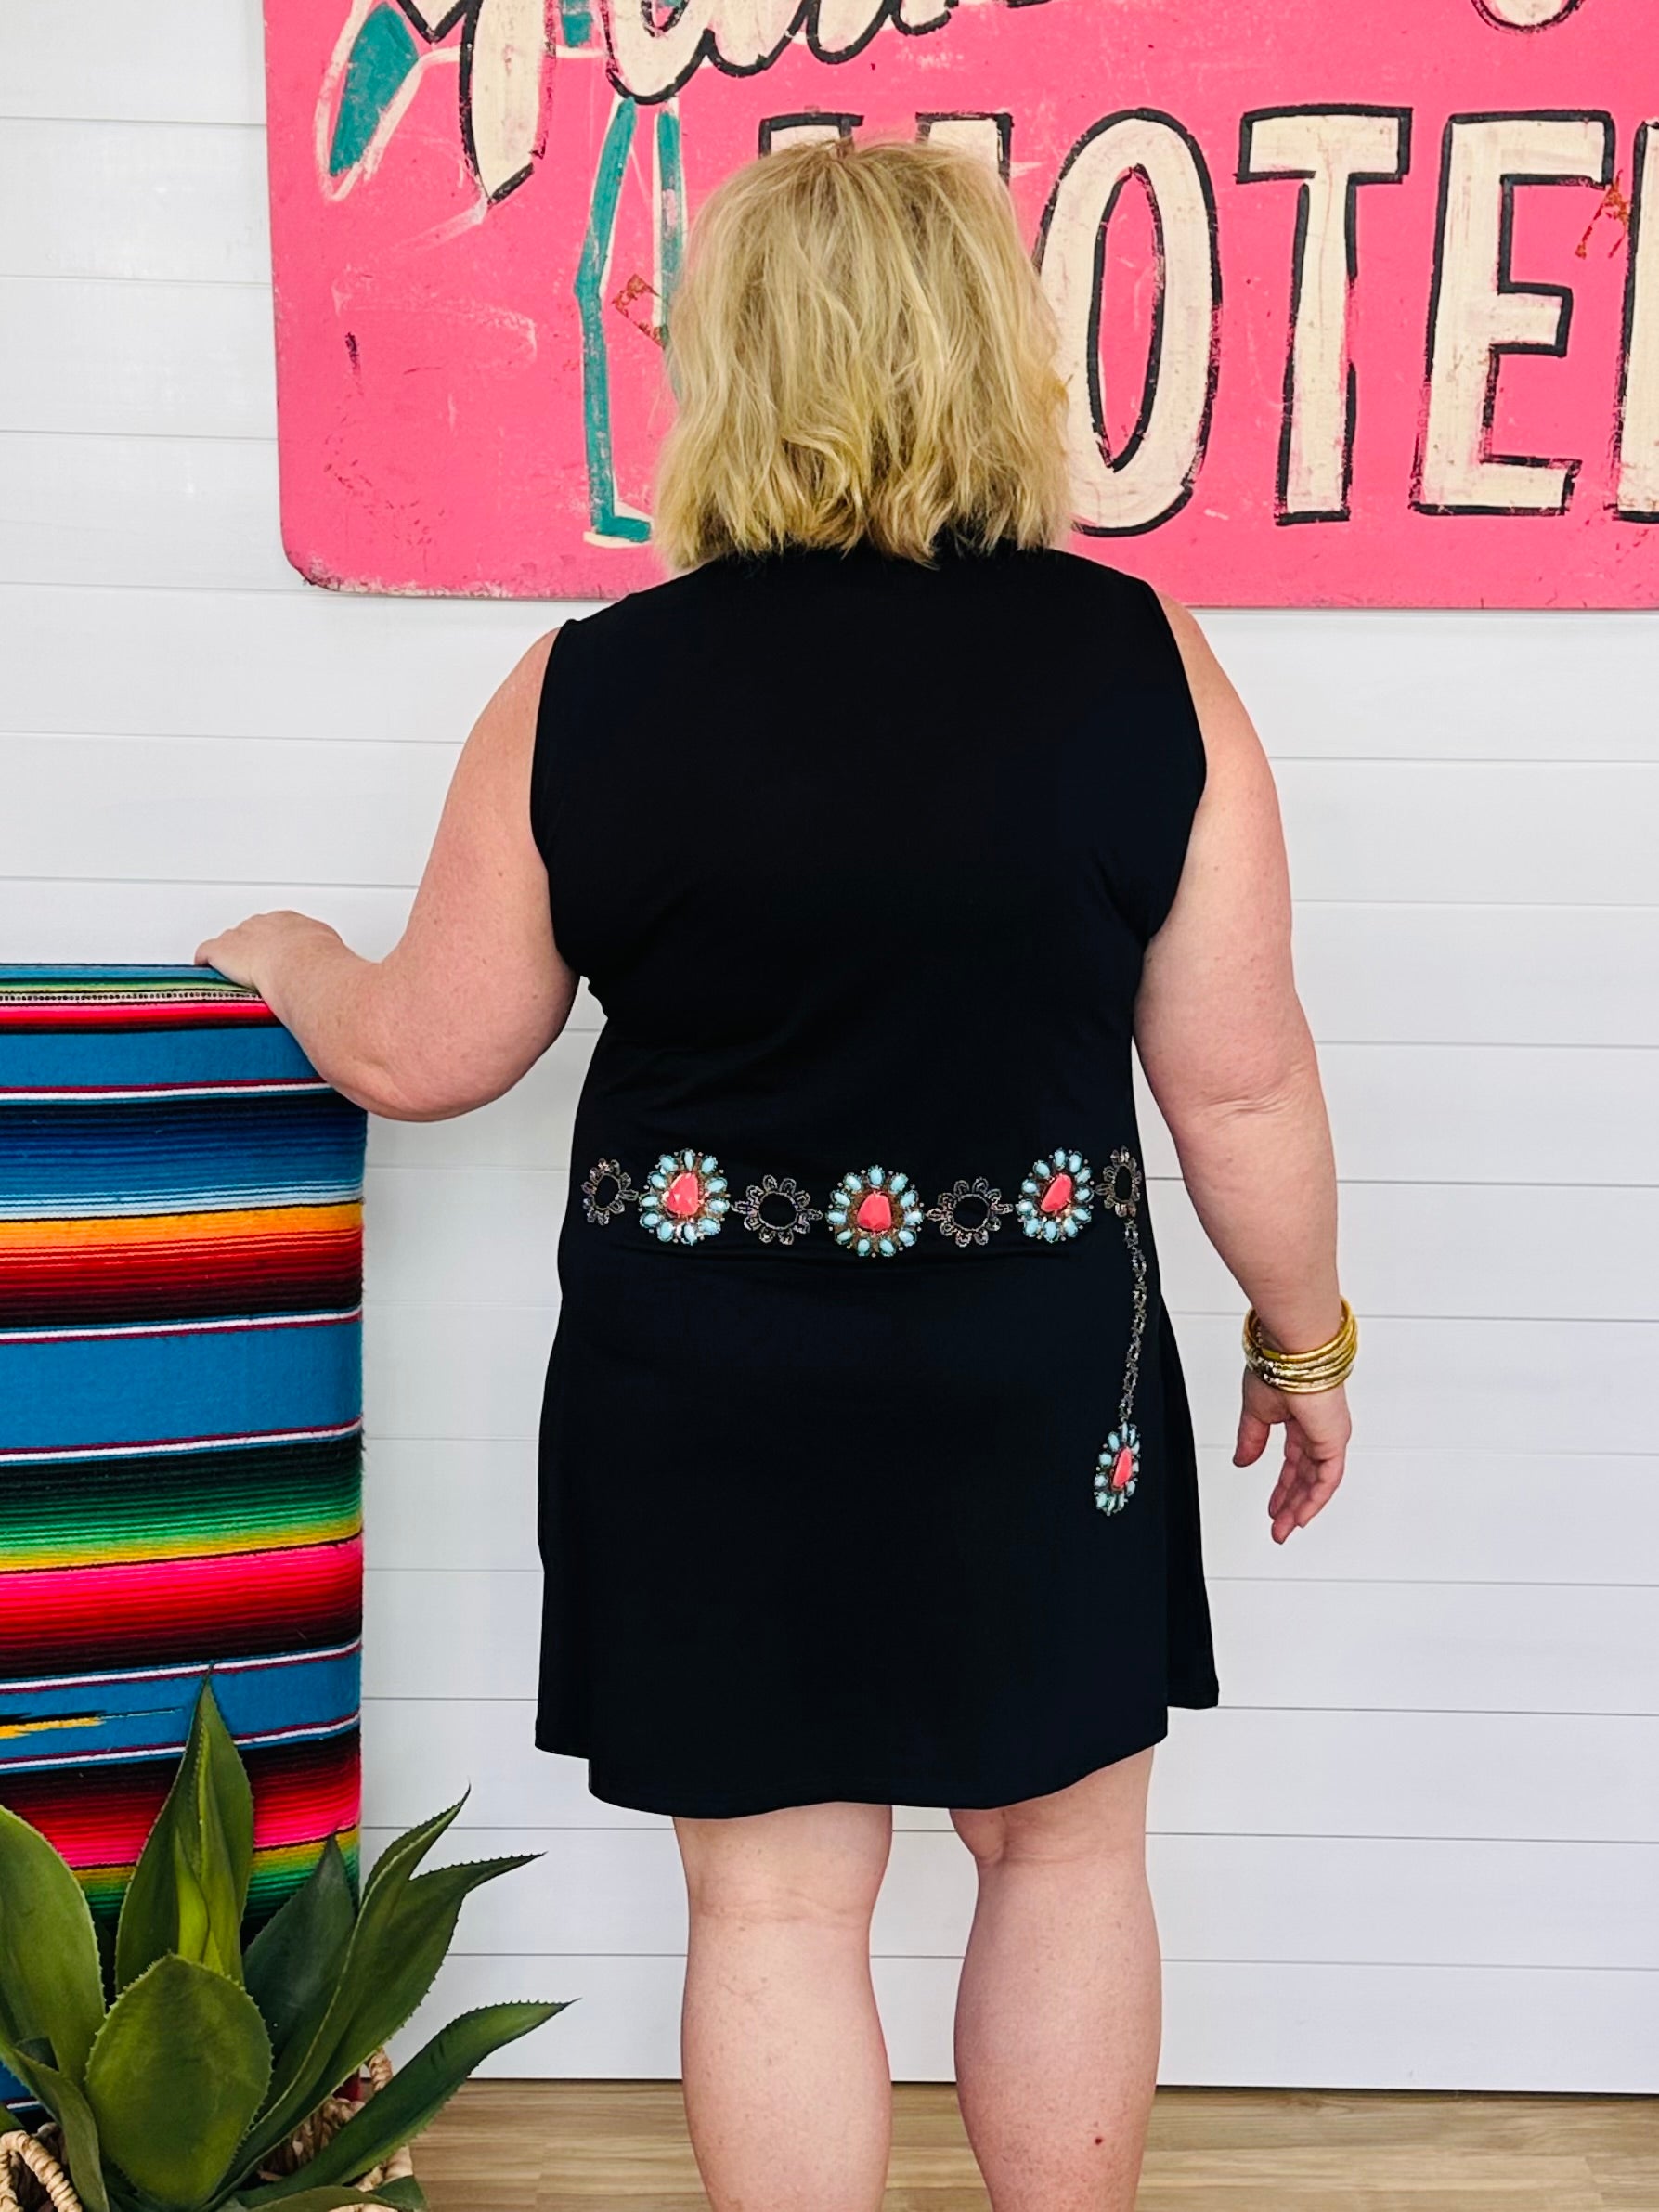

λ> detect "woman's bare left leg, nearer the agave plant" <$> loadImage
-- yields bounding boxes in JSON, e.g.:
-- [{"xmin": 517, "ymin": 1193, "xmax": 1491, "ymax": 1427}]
[{"xmin": 675, "ymin": 1805, "xmax": 894, "ymax": 2212}]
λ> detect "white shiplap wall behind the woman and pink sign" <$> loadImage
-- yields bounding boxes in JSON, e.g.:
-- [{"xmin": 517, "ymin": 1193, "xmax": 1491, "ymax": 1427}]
[{"xmin": 0, "ymin": 0, "xmax": 1659, "ymax": 2090}]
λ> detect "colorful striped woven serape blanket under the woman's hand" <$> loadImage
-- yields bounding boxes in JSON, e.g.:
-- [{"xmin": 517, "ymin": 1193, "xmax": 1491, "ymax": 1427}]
[{"xmin": 0, "ymin": 966, "xmax": 365, "ymax": 1990}]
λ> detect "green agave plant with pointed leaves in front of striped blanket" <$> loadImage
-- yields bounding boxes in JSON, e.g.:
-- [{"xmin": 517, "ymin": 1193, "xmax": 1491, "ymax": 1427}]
[{"xmin": 0, "ymin": 1681, "xmax": 564, "ymax": 2212}]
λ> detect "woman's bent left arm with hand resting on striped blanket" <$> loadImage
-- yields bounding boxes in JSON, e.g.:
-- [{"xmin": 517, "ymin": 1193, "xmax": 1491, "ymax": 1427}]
[{"xmin": 197, "ymin": 637, "xmax": 575, "ymax": 1121}]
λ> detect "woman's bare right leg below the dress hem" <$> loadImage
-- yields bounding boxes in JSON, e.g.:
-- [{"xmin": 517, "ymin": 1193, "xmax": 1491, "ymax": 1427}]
[{"xmin": 952, "ymin": 1752, "xmax": 1161, "ymax": 2212}]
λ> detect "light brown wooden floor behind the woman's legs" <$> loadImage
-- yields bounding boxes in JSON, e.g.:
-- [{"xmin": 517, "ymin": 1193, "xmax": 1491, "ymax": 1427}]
[{"xmin": 416, "ymin": 2081, "xmax": 1659, "ymax": 2212}]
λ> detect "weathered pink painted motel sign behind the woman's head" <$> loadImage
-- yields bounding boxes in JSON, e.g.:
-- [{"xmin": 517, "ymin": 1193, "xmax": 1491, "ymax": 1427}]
[{"xmin": 266, "ymin": 0, "xmax": 1659, "ymax": 606}]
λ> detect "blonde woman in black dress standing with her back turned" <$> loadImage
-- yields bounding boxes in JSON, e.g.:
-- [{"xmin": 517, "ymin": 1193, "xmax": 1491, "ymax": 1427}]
[{"xmin": 197, "ymin": 144, "xmax": 1354, "ymax": 2212}]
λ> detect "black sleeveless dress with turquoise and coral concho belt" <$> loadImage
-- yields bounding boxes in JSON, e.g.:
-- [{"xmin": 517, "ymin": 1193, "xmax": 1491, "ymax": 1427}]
[{"xmin": 531, "ymin": 547, "xmax": 1219, "ymax": 1816}]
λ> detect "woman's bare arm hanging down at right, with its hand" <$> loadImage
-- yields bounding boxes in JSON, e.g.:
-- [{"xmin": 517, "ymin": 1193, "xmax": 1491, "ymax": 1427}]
[{"xmin": 1134, "ymin": 600, "xmax": 1349, "ymax": 1542}]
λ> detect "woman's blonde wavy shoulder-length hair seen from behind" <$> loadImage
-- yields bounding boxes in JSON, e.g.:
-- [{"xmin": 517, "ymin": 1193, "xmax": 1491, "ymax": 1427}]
[{"xmin": 653, "ymin": 139, "xmax": 1070, "ymax": 568}]
